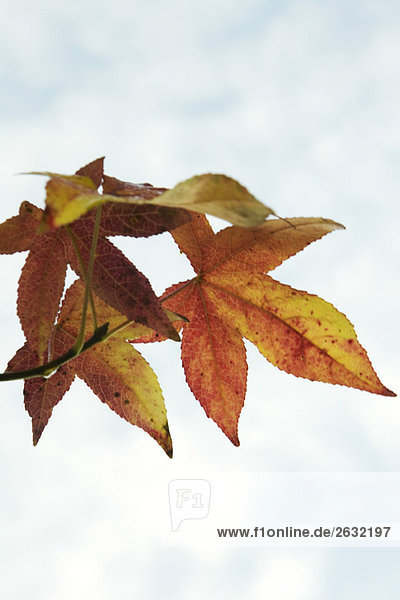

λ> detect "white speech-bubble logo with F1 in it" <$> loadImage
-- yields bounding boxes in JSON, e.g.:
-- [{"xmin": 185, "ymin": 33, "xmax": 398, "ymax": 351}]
[{"xmin": 168, "ymin": 479, "xmax": 211, "ymax": 531}]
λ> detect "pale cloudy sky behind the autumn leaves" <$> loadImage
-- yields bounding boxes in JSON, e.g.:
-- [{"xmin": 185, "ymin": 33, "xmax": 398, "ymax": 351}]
[{"xmin": 0, "ymin": 0, "xmax": 400, "ymax": 600}]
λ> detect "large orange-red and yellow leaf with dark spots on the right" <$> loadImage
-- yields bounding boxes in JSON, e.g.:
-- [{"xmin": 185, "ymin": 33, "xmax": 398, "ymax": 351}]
[{"xmin": 152, "ymin": 215, "xmax": 395, "ymax": 445}]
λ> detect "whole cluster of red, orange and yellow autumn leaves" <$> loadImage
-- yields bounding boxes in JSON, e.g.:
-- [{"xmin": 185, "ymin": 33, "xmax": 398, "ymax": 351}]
[{"xmin": 0, "ymin": 159, "xmax": 394, "ymax": 456}]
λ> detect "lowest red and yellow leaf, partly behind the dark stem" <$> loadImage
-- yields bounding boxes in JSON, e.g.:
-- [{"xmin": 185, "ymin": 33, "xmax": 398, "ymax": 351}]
[{"xmin": 8, "ymin": 280, "xmax": 172, "ymax": 456}]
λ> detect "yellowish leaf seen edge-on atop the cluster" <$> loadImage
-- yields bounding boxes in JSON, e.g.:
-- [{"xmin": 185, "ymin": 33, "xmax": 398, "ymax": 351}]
[{"xmin": 32, "ymin": 165, "xmax": 275, "ymax": 228}]
